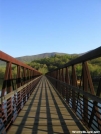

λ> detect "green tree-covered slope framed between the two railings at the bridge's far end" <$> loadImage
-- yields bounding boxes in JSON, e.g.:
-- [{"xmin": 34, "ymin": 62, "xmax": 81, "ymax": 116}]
[{"xmin": 28, "ymin": 54, "xmax": 78, "ymax": 74}]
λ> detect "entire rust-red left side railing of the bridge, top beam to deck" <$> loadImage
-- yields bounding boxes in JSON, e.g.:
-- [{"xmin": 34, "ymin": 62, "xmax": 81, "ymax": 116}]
[{"xmin": 0, "ymin": 51, "xmax": 42, "ymax": 134}]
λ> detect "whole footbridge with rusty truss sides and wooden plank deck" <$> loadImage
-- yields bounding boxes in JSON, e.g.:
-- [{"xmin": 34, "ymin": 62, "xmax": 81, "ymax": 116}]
[{"xmin": 0, "ymin": 47, "xmax": 101, "ymax": 134}]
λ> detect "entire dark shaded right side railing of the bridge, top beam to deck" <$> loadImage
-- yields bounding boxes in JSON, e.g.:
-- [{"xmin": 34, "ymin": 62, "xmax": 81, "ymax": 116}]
[{"xmin": 46, "ymin": 47, "xmax": 101, "ymax": 131}]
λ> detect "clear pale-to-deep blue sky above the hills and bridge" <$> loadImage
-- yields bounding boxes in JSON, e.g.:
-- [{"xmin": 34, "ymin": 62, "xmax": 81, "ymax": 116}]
[{"xmin": 0, "ymin": 0, "xmax": 101, "ymax": 57}]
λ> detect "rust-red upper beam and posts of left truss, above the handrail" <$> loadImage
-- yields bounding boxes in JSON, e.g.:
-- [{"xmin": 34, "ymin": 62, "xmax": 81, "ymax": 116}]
[{"xmin": 0, "ymin": 51, "xmax": 41, "ymax": 96}]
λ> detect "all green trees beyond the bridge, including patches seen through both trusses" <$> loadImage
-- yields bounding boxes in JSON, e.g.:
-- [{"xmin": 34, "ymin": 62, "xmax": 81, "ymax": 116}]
[{"xmin": 0, "ymin": 54, "xmax": 101, "ymax": 89}]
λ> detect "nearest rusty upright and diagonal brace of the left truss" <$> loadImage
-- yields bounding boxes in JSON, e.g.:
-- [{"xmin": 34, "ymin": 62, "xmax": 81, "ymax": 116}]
[{"xmin": 1, "ymin": 62, "xmax": 13, "ymax": 130}]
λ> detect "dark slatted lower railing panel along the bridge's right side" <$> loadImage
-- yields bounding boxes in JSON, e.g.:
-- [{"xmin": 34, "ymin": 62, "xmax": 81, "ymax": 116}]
[{"xmin": 47, "ymin": 75, "xmax": 101, "ymax": 131}]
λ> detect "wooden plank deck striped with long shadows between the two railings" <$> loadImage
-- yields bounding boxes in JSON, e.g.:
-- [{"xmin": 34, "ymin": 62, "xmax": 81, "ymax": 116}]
[{"xmin": 7, "ymin": 77, "xmax": 85, "ymax": 134}]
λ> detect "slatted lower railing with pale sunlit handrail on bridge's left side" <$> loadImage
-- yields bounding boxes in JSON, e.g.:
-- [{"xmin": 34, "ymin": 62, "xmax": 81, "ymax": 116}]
[{"xmin": 0, "ymin": 76, "xmax": 41, "ymax": 134}]
